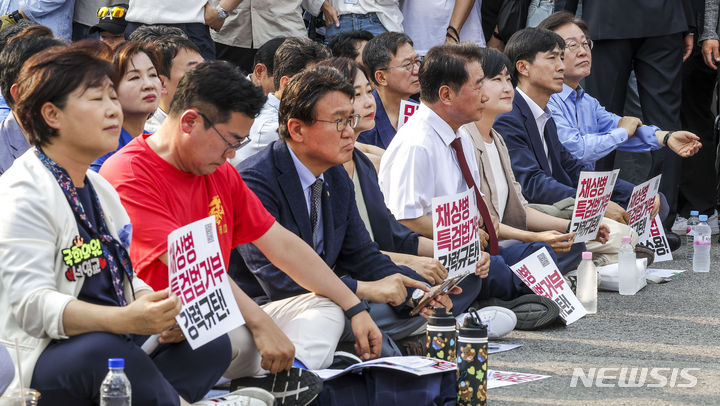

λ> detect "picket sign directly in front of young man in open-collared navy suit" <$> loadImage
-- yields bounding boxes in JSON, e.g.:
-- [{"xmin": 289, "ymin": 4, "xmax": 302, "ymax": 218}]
[{"xmin": 570, "ymin": 169, "xmax": 620, "ymax": 242}]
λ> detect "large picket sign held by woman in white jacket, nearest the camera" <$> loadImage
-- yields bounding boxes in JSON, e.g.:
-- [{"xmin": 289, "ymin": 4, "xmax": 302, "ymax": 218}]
[{"xmin": 168, "ymin": 215, "xmax": 245, "ymax": 349}]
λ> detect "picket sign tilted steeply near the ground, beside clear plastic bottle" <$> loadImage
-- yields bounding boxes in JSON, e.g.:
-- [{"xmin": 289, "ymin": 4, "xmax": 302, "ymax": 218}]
[{"xmin": 510, "ymin": 247, "xmax": 587, "ymax": 325}]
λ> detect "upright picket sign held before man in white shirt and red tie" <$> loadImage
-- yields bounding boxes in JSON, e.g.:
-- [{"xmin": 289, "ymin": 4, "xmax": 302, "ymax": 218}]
[{"xmin": 432, "ymin": 188, "xmax": 480, "ymax": 278}]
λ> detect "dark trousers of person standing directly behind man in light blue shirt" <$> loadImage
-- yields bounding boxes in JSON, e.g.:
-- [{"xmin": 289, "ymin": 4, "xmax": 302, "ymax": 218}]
[{"xmin": 585, "ymin": 33, "xmax": 683, "ymax": 229}]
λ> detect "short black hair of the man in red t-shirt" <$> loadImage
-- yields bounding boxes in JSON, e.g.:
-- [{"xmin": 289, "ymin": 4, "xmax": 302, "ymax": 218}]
[{"xmin": 168, "ymin": 61, "xmax": 265, "ymax": 128}]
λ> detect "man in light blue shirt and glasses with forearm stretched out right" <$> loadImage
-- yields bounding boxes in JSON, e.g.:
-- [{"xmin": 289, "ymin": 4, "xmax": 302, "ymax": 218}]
[{"xmin": 539, "ymin": 15, "xmax": 701, "ymax": 170}]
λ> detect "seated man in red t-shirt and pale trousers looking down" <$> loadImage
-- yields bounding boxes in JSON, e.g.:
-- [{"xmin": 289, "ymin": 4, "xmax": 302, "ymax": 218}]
[{"xmin": 100, "ymin": 62, "xmax": 380, "ymax": 402}]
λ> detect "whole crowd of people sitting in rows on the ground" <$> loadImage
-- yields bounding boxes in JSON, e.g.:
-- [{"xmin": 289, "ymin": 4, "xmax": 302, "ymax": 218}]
[{"xmin": 0, "ymin": 0, "xmax": 701, "ymax": 405}]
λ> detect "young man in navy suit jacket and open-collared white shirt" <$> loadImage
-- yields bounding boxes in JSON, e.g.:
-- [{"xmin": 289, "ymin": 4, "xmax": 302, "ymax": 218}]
[{"xmin": 493, "ymin": 28, "xmax": 634, "ymax": 222}]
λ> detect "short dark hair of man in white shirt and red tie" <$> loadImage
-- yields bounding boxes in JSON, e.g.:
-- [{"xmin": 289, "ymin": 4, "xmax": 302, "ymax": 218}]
[{"xmin": 418, "ymin": 42, "xmax": 484, "ymax": 103}]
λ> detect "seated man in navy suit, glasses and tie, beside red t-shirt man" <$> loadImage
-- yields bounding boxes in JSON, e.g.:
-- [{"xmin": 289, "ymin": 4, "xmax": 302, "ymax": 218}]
[{"xmin": 238, "ymin": 67, "xmax": 469, "ymax": 356}]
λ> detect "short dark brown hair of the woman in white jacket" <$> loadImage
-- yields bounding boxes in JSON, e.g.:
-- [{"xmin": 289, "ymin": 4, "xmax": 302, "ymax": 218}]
[{"xmin": 15, "ymin": 47, "xmax": 113, "ymax": 147}]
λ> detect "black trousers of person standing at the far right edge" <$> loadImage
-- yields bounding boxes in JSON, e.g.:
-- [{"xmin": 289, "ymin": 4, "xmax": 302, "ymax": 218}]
[{"xmin": 678, "ymin": 44, "xmax": 717, "ymax": 218}]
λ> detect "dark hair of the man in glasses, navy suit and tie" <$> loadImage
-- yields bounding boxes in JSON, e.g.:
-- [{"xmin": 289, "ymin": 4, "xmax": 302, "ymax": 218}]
[{"xmin": 278, "ymin": 66, "xmax": 355, "ymax": 140}]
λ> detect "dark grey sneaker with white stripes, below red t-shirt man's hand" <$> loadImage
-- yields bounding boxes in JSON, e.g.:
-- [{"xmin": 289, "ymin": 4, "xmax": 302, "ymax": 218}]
[{"xmin": 230, "ymin": 368, "xmax": 323, "ymax": 406}]
